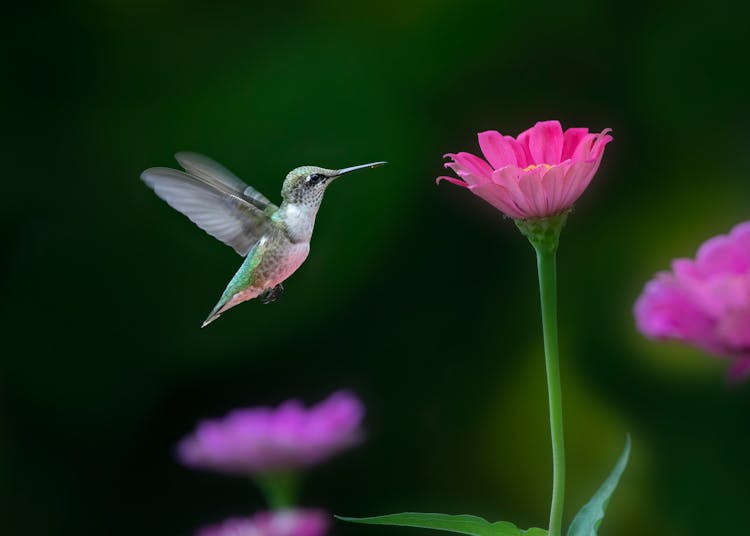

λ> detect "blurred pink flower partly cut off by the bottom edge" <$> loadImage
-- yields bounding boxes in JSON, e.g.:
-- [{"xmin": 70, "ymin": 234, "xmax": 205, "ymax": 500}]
[{"xmin": 196, "ymin": 510, "xmax": 329, "ymax": 536}]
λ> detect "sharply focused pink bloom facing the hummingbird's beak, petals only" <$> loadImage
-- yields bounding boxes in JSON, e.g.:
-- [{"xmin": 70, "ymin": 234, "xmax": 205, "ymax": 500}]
[{"xmin": 438, "ymin": 121, "xmax": 612, "ymax": 219}]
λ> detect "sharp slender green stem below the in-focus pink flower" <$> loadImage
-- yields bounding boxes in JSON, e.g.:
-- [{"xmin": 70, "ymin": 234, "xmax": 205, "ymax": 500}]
[{"xmin": 534, "ymin": 247, "xmax": 565, "ymax": 536}]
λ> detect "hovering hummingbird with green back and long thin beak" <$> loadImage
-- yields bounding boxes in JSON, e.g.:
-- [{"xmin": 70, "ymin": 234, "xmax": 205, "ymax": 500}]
[{"xmin": 141, "ymin": 152, "xmax": 386, "ymax": 327}]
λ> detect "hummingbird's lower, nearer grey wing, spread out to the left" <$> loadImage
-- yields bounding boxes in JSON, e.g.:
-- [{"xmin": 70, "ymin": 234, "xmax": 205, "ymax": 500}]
[{"xmin": 141, "ymin": 168, "xmax": 271, "ymax": 257}]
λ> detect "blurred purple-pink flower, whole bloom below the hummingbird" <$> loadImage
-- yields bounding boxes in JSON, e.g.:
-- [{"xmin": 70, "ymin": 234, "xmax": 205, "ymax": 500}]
[{"xmin": 177, "ymin": 391, "xmax": 364, "ymax": 474}]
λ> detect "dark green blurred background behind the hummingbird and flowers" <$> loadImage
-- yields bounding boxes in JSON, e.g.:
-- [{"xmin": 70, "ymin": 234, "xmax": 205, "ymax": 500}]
[{"xmin": 0, "ymin": 0, "xmax": 750, "ymax": 536}]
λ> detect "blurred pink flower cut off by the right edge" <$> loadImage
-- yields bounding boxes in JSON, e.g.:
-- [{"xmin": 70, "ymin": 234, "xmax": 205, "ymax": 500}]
[{"xmin": 635, "ymin": 222, "xmax": 750, "ymax": 379}]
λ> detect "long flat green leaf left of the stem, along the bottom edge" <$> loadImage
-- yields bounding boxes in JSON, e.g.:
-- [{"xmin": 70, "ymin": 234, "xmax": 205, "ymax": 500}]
[{"xmin": 336, "ymin": 512, "xmax": 547, "ymax": 536}]
